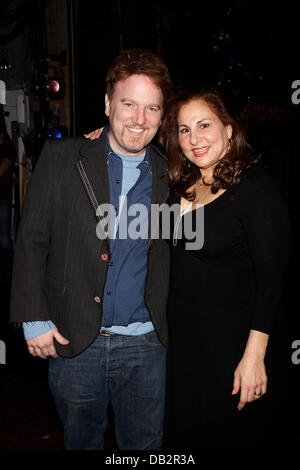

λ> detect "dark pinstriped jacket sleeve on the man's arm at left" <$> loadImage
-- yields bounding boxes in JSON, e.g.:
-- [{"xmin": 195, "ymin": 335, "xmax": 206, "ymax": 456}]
[{"xmin": 10, "ymin": 141, "xmax": 56, "ymax": 322}]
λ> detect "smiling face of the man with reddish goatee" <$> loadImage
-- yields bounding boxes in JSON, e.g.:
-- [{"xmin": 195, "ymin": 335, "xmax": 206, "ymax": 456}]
[{"xmin": 105, "ymin": 75, "xmax": 163, "ymax": 156}]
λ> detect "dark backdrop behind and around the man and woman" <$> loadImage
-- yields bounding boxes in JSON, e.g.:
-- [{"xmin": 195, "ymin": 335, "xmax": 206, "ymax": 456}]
[{"xmin": 0, "ymin": 0, "xmax": 300, "ymax": 456}]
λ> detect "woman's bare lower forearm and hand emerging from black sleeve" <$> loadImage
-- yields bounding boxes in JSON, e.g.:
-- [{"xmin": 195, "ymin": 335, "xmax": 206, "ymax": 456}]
[{"xmin": 231, "ymin": 330, "xmax": 269, "ymax": 411}]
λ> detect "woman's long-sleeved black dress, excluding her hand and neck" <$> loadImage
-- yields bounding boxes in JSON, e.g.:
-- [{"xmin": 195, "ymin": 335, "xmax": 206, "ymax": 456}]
[{"xmin": 164, "ymin": 165, "xmax": 290, "ymax": 451}]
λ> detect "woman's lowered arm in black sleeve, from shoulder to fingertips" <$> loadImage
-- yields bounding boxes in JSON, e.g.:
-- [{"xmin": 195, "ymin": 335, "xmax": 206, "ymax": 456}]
[{"xmin": 232, "ymin": 167, "xmax": 291, "ymax": 410}]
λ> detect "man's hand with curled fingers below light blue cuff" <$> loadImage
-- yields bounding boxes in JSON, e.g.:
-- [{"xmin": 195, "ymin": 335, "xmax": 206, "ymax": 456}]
[{"xmin": 26, "ymin": 328, "xmax": 70, "ymax": 359}]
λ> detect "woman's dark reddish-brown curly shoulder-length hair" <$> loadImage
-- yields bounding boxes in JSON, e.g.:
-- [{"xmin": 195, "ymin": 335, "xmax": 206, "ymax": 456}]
[{"xmin": 159, "ymin": 88, "xmax": 260, "ymax": 201}]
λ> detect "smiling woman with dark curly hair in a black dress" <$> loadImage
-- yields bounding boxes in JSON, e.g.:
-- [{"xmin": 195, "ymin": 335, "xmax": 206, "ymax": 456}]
[{"xmin": 160, "ymin": 90, "xmax": 290, "ymax": 450}]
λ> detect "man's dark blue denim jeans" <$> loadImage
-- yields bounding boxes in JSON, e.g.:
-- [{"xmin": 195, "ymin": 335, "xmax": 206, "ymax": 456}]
[{"xmin": 49, "ymin": 331, "xmax": 166, "ymax": 450}]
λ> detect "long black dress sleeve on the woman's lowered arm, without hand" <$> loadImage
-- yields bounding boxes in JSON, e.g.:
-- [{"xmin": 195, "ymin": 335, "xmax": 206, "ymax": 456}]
[{"xmin": 241, "ymin": 168, "xmax": 291, "ymax": 334}]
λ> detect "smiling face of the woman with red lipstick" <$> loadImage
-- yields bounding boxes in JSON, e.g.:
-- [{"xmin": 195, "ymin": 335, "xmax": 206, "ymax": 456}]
[{"xmin": 178, "ymin": 99, "xmax": 232, "ymax": 169}]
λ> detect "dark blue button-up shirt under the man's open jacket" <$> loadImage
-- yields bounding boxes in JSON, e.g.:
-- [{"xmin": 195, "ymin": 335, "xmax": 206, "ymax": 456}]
[{"xmin": 102, "ymin": 132, "xmax": 152, "ymax": 327}]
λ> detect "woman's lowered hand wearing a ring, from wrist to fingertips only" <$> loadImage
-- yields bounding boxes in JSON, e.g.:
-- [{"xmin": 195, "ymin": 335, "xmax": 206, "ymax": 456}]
[{"xmin": 232, "ymin": 354, "xmax": 268, "ymax": 411}]
